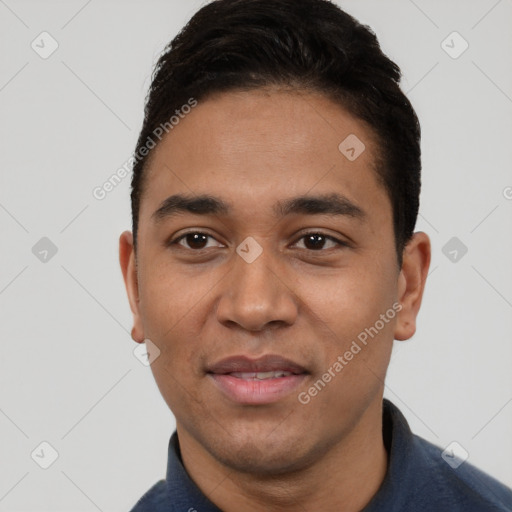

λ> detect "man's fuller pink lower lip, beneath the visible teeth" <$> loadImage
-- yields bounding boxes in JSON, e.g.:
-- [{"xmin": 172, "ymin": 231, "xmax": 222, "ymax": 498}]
[{"xmin": 209, "ymin": 373, "xmax": 306, "ymax": 405}]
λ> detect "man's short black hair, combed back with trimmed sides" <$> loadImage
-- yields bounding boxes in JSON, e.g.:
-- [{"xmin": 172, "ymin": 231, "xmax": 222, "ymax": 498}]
[{"xmin": 131, "ymin": 0, "xmax": 421, "ymax": 268}]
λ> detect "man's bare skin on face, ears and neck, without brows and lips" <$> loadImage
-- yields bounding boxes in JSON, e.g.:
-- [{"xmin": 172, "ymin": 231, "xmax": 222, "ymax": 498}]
[{"xmin": 119, "ymin": 89, "xmax": 430, "ymax": 512}]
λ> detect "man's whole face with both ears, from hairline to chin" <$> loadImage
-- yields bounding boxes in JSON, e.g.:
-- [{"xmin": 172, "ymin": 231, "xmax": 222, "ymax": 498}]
[{"xmin": 120, "ymin": 90, "xmax": 429, "ymax": 474}]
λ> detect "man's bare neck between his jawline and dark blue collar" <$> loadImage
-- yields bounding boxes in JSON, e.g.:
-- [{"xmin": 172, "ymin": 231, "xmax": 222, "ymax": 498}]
[{"xmin": 177, "ymin": 402, "xmax": 388, "ymax": 512}]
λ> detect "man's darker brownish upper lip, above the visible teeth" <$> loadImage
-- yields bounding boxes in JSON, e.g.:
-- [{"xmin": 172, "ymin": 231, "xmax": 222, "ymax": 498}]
[{"xmin": 207, "ymin": 354, "xmax": 308, "ymax": 375}]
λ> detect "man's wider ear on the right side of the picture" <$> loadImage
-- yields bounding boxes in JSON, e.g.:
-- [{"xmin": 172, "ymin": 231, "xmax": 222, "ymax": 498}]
[{"xmin": 395, "ymin": 232, "xmax": 430, "ymax": 341}]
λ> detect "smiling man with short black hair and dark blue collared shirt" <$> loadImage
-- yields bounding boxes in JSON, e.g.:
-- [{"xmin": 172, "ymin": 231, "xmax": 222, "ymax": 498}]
[{"xmin": 120, "ymin": 0, "xmax": 512, "ymax": 512}]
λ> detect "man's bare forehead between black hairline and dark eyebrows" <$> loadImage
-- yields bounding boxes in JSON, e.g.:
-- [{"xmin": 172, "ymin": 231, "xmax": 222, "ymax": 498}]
[{"xmin": 141, "ymin": 89, "xmax": 390, "ymax": 222}]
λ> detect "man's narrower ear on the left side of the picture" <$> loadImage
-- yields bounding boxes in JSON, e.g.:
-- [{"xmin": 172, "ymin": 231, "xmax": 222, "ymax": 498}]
[{"xmin": 119, "ymin": 231, "xmax": 144, "ymax": 343}]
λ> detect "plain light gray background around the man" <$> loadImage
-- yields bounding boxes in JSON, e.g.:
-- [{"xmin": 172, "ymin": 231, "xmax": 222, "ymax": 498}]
[{"xmin": 0, "ymin": 0, "xmax": 512, "ymax": 512}]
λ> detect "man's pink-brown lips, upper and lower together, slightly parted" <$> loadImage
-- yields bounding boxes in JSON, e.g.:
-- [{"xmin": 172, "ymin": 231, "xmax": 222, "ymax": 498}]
[{"xmin": 207, "ymin": 354, "xmax": 309, "ymax": 405}]
